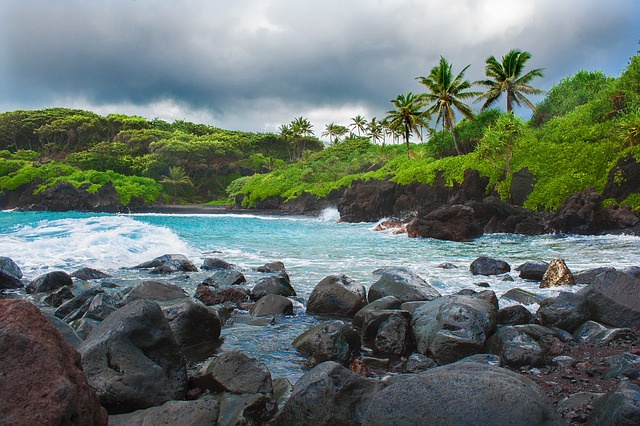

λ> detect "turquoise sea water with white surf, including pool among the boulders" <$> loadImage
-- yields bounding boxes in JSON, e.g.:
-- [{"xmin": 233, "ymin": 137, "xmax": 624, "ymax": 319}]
[{"xmin": 0, "ymin": 209, "xmax": 640, "ymax": 380}]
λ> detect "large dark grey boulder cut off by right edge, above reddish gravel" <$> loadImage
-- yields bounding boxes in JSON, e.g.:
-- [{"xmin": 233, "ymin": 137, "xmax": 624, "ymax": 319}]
[{"xmin": 579, "ymin": 271, "xmax": 640, "ymax": 327}]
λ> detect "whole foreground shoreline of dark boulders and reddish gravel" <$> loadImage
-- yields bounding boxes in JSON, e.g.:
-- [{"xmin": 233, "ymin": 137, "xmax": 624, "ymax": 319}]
[{"xmin": 0, "ymin": 255, "xmax": 640, "ymax": 425}]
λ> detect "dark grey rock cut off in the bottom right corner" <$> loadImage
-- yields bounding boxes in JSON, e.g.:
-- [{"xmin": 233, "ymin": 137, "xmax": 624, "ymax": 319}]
[{"xmin": 589, "ymin": 381, "xmax": 640, "ymax": 426}]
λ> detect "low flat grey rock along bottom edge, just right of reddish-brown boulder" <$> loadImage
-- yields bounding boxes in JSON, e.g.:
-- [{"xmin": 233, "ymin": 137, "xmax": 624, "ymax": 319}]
[{"xmin": 109, "ymin": 398, "xmax": 220, "ymax": 426}]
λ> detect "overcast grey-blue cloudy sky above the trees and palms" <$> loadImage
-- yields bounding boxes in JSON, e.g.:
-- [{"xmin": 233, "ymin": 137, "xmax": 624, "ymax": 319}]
[{"xmin": 0, "ymin": 0, "xmax": 640, "ymax": 135}]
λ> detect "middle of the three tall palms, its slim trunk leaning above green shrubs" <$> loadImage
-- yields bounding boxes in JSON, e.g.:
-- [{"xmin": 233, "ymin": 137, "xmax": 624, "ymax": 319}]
[{"xmin": 417, "ymin": 56, "xmax": 480, "ymax": 154}]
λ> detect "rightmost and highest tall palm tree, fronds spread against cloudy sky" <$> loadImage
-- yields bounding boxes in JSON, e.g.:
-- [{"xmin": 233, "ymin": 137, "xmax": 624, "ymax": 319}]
[{"xmin": 475, "ymin": 49, "xmax": 544, "ymax": 112}]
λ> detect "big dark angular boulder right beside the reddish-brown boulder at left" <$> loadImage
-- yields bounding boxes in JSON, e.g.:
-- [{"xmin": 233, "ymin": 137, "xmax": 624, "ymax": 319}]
[{"xmin": 79, "ymin": 299, "xmax": 187, "ymax": 414}]
